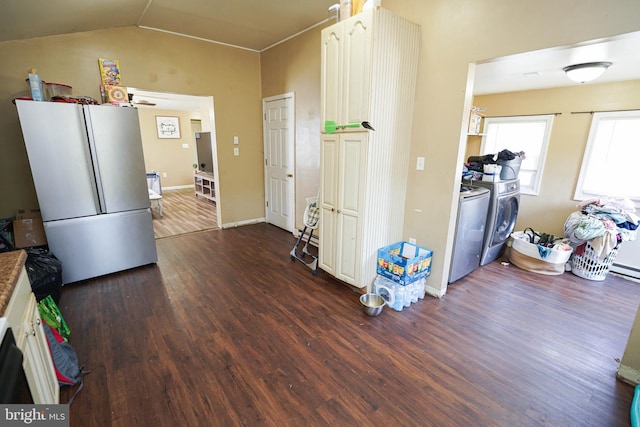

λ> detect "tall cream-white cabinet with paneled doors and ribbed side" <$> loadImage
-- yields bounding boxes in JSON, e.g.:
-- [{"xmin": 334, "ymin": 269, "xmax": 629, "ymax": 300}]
[{"xmin": 319, "ymin": 8, "xmax": 420, "ymax": 288}]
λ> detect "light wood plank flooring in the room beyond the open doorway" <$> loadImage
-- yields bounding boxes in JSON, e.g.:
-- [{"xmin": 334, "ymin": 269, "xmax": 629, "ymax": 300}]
[{"xmin": 152, "ymin": 188, "xmax": 218, "ymax": 239}]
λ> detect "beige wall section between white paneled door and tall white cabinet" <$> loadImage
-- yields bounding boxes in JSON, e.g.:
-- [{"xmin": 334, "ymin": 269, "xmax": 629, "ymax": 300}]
[{"xmin": 261, "ymin": 28, "xmax": 321, "ymax": 229}]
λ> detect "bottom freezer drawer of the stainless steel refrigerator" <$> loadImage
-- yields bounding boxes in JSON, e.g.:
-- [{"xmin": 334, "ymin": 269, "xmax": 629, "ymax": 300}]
[{"xmin": 44, "ymin": 209, "xmax": 158, "ymax": 284}]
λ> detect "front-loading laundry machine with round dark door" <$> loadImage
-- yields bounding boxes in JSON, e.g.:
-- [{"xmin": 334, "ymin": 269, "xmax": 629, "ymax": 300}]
[{"xmin": 473, "ymin": 179, "xmax": 520, "ymax": 265}]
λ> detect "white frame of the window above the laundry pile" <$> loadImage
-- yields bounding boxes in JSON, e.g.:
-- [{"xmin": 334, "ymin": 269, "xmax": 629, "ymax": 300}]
[{"xmin": 573, "ymin": 110, "xmax": 640, "ymax": 208}]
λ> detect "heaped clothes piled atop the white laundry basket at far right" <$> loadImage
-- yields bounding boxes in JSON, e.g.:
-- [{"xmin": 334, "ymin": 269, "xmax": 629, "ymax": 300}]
[{"xmin": 564, "ymin": 198, "xmax": 639, "ymax": 260}]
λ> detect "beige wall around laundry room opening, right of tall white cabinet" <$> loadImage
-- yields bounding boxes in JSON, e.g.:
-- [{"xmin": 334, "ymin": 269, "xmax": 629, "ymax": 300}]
[{"xmin": 384, "ymin": 0, "xmax": 640, "ymax": 295}]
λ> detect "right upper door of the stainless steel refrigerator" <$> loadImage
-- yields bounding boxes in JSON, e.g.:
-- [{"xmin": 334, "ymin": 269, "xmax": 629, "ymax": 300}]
[{"xmin": 84, "ymin": 105, "xmax": 150, "ymax": 213}]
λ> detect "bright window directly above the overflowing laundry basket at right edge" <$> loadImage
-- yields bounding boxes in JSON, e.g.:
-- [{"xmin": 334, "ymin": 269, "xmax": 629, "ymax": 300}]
[{"xmin": 574, "ymin": 110, "xmax": 640, "ymax": 207}]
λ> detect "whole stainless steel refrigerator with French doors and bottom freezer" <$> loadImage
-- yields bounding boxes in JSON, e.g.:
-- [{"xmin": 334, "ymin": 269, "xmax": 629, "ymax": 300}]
[{"xmin": 16, "ymin": 100, "xmax": 158, "ymax": 284}]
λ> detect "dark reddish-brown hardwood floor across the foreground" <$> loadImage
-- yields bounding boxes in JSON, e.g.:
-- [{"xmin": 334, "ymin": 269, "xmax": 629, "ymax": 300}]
[{"xmin": 60, "ymin": 224, "xmax": 640, "ymax": 427}]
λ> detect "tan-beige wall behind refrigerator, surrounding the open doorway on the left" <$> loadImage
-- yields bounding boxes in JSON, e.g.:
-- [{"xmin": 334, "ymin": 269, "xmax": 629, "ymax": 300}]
[{"xmin": 0, "ymin": 27, "xmax": 264, "ymax": 224}]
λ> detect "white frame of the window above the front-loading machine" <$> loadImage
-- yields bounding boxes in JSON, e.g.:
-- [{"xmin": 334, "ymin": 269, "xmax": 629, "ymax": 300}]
[{"xmin": 480, "ymin": 114, "xmax": 555, "ymax": 196}]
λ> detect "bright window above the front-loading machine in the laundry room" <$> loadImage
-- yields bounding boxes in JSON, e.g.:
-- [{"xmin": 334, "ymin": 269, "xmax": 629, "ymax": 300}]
[{"xmin": 480, "ymin": 114, "xmax": 554, "ymax": 195}]
